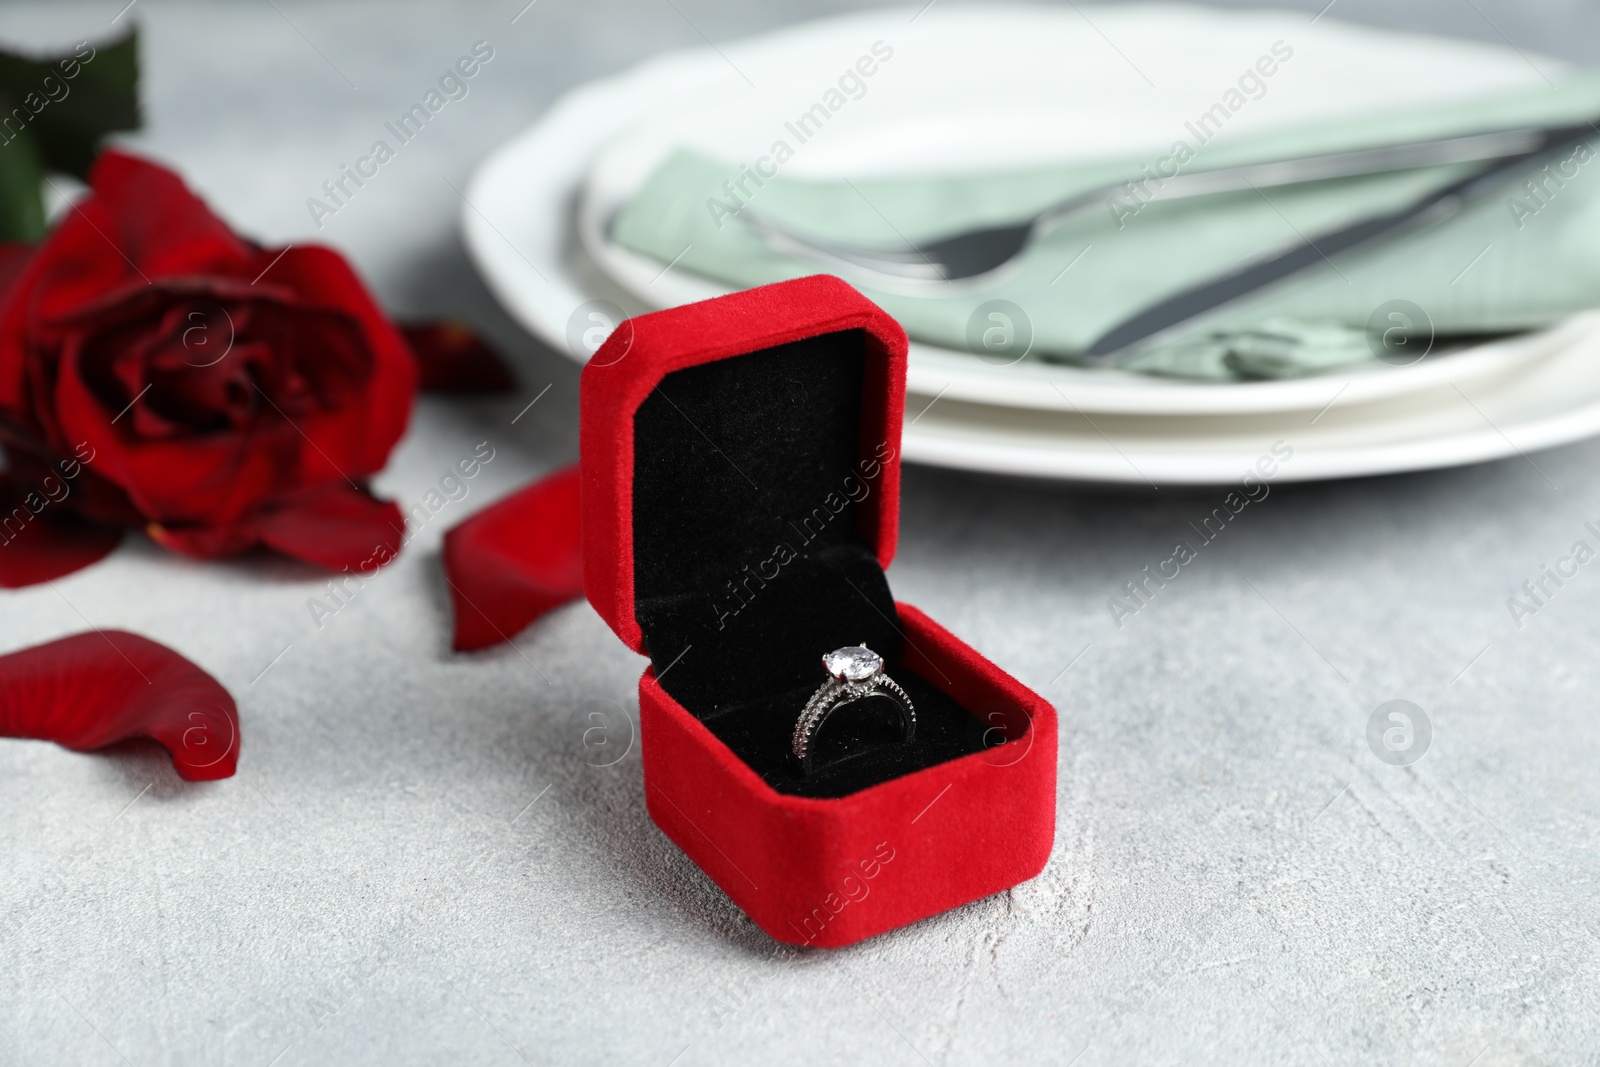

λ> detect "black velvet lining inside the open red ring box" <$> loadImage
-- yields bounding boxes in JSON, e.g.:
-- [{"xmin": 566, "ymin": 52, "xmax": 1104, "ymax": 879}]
[{"xmin": 634, "ymin": 330, "xmax": 982, "ymax": 797}]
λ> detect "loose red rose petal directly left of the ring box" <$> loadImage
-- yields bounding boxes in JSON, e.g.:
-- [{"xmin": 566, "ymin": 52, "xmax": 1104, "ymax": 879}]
[{"xmin": 445, "ymin": 464, "xmax": 584, "ymax": 651}]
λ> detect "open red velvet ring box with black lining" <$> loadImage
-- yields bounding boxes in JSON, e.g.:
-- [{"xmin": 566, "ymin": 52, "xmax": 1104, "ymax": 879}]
[{"xmin": 581, "ymin": 277, "xmax": 1056, "ymax": 947}]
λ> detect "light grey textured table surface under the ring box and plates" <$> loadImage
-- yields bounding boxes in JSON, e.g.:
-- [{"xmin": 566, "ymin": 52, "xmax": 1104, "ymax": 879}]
[{"xmin": 0, "ymin": 0, "xmax": 1600, "ymax": 1067}]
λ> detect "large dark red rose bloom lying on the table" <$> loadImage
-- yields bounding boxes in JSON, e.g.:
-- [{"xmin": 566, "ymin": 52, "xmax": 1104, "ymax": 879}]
[{"xmin": 0, "ymin": 152, "xmax": 418, "ymax": 584}]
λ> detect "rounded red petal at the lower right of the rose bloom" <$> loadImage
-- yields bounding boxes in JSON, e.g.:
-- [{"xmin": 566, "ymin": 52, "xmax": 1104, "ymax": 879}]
[{"xmin": 254, "ymin": 485, "xmax": 405, "ymax": 574}]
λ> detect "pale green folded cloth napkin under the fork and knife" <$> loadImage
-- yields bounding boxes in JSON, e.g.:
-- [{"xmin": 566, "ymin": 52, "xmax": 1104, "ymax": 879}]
[{"xmin": 611, "ymin": 72, "xmax": 1600, "ymax": 381}]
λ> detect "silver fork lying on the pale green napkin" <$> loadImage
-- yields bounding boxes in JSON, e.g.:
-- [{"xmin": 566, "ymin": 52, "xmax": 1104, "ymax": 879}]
[{"xmin": 739, "ymin": 126, "xmax": 1552, "ymax": 288}]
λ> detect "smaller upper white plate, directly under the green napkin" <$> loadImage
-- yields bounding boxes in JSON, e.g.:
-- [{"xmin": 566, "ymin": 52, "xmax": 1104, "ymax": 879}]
[{"xmin": 578, "ymin": 6, "xmax": 1561, "ymax": 414}]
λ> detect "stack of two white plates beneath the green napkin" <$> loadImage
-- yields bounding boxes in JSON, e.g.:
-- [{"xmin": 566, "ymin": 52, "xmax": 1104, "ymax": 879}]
[{"xmin": 462, "ymin": 3, "xmax": 1600, "ymax": 485}]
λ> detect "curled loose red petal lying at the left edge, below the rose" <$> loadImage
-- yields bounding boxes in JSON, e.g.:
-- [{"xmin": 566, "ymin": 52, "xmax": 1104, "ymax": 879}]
[{"xmin": 0, "ymin": 630, "xmax": 238, "ymax": 782}]
